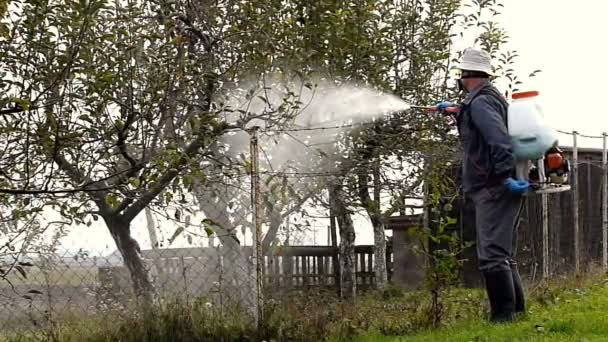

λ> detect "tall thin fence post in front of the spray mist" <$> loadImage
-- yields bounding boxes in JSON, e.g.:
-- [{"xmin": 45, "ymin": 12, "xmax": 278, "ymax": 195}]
[{"xmin": 249, "ymin": 127, "xmax": 264, "ymax": 333}]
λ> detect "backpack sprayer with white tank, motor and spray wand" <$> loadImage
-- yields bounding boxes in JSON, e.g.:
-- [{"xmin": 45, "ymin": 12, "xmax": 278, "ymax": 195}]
[{"xmin": 418, "ymin": 91, "xmax": 570, "ymax": 193}]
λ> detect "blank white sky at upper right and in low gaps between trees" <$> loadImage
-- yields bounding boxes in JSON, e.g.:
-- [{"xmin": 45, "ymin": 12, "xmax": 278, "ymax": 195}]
[{"xmin": 20, "ymin": 0, "xmax": 608, "ymax": 255}]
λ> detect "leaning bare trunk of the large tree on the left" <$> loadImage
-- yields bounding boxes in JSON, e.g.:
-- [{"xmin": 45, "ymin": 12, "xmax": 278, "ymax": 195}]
[{"xmin": 104, "ymin": 217, "xmax": 156, "ymax": 304}]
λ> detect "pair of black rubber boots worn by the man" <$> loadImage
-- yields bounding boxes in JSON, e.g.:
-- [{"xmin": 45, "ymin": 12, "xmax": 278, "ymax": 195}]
[{"xmin": 484, "ymin": 269, "xmax": 515, "ymax": 323}]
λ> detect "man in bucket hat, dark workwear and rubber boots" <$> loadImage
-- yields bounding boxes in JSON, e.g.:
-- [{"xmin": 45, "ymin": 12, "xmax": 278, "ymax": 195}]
[{"xmin": 438, "ymin": 49, "xmax": 529, "ymax": 322}]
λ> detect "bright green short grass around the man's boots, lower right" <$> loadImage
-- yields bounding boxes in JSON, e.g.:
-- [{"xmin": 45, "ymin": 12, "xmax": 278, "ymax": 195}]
[{"xmin": 357, "ymin": 282, "xmax": 608, "ymax": 342}]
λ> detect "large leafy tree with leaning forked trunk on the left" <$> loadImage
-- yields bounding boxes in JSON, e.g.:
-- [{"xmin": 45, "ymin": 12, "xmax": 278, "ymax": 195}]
[{"xmin": 0, "ymin": 0, "xmax": 300, "ymax": 302}]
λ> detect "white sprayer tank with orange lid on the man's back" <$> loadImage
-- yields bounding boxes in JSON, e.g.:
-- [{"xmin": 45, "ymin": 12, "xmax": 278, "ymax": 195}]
[{"xmin": 508, "ymin": 91, "xmax": 557, "ymax": 161}]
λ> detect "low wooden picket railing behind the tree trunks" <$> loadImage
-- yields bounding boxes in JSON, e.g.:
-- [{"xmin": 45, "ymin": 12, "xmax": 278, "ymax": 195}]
[{"xmin": 99, "ymin": 245, "xmax": 393, "ymax": 295}]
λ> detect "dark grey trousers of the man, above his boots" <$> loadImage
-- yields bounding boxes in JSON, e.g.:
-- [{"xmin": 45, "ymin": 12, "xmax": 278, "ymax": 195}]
[{"xmin": 470, "ymin": 186, "xmax": 524, "ymax": 272}]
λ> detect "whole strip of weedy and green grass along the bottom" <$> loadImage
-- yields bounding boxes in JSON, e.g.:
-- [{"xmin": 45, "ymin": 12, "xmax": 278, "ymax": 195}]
[{"xmin": 0, "ymin": 276, "xmax": 608, "ymax": 342}]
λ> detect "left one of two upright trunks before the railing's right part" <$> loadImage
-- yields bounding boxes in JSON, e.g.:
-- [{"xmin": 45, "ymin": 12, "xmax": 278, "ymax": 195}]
[{"xmin": 332, "ymin": 185, "xmax": 357, "ymax": 300}]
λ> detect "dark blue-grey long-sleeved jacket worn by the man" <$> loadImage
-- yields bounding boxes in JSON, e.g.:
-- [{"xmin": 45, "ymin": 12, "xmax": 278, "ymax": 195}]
[{"xmin": 457, "ymin": 82, "xmax": 515, "ymax": 193}]
